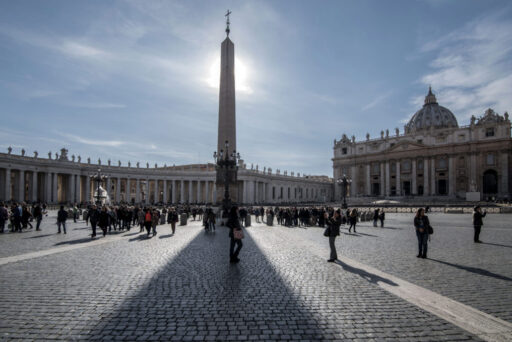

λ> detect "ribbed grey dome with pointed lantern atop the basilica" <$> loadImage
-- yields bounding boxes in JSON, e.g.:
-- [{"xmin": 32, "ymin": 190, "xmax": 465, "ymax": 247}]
[{"xmin": 405, "ymin": 87, "xmax": 459, "ymax": 133}]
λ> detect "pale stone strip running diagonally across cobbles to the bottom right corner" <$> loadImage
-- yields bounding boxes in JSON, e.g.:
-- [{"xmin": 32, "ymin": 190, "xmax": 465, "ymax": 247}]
[{"xmin": 251, "ymin": 228, "xmax": 512, "ymax": 342}]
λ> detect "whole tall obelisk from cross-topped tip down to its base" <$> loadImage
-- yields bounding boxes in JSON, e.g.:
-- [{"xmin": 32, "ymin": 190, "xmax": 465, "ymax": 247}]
[{"xmin": 216, "ymin": 10, "xmax": 238, "ymax": 206}]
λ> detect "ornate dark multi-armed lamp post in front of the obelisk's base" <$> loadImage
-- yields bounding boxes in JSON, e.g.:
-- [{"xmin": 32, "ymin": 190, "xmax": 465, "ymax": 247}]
[{"xmin": 213, "ymin": 140, "xmax": 240, "ymax": 214}]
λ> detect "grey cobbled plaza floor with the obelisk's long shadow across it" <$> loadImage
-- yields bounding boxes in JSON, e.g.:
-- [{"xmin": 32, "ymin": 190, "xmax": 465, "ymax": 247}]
[{"xmin": 0, "ymin": 214, "xmax": 512, "ymax": 341}]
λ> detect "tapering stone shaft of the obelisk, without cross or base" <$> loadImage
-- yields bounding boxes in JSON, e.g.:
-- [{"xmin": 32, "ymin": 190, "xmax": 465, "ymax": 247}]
[{"xmin": 217, "ymin": 37, "xmax": 236, "ymax": 155}]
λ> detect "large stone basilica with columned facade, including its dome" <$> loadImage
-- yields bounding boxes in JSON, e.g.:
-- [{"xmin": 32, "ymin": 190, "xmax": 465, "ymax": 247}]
[{"xmin": 332, "ymin": 89, "xmax": 512, "ymax": 200}]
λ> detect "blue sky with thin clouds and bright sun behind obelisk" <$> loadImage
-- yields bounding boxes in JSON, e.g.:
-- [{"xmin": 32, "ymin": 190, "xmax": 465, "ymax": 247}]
[{"xmin": 0, "ymin": 0, "xmax": 512, "ymax": 176}]
